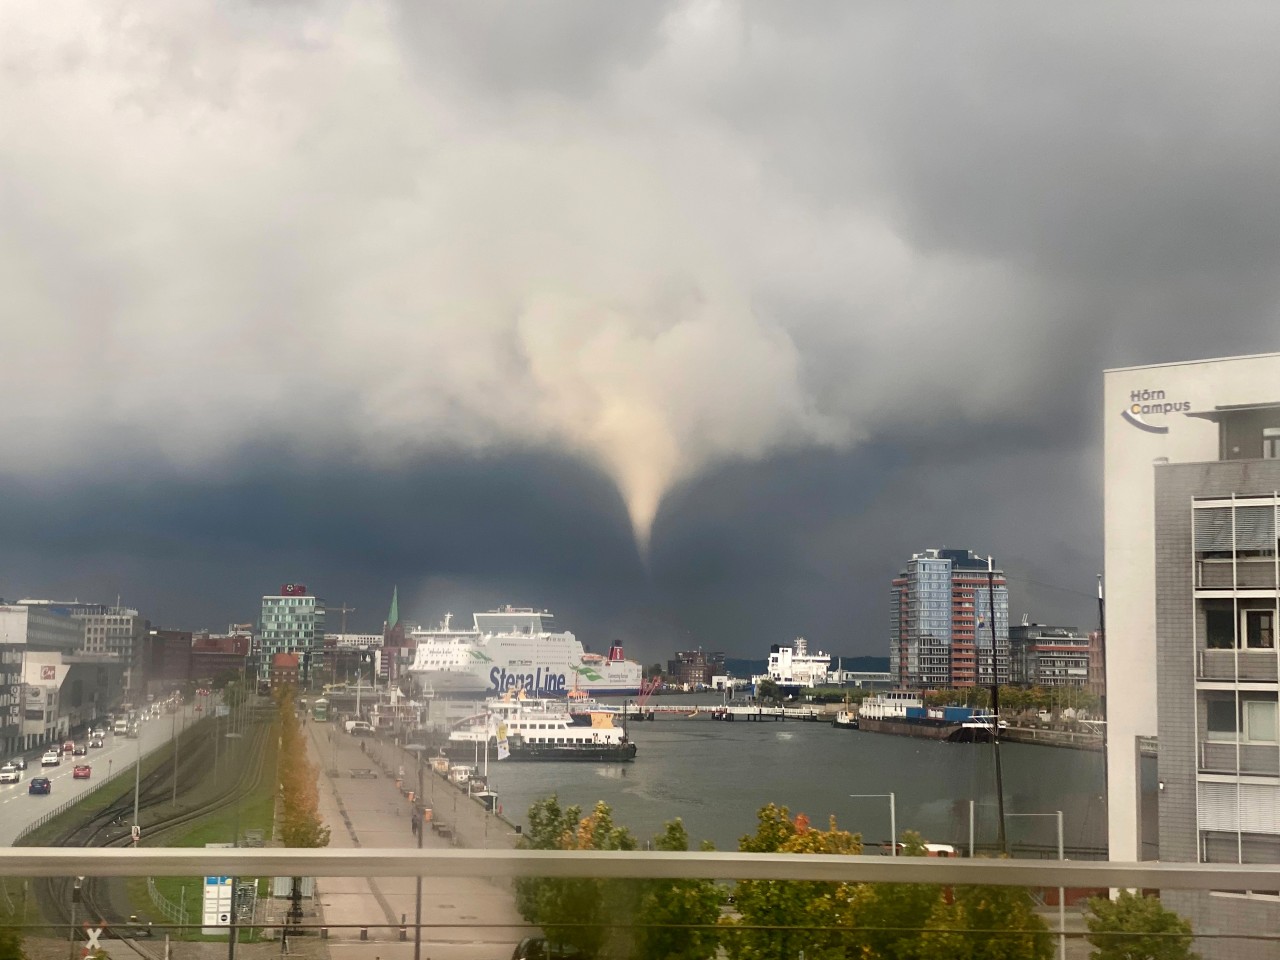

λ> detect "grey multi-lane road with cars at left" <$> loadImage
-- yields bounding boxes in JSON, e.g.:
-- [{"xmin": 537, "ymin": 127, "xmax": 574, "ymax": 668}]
[{"xmin": 0, "ymin": 700, "xmax": 209, "ymax": 846}]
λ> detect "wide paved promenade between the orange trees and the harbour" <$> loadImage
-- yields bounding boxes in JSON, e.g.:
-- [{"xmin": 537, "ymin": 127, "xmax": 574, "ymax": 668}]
[{"xmin": 307, "ymin": 723, "xmax": 527, "ymax": 960}]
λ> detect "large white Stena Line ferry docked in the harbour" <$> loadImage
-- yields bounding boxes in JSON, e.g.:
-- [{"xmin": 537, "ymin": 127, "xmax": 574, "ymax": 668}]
[{"xmin": 408, "ymin": 607, "xmax": 643, "ymax": 698}]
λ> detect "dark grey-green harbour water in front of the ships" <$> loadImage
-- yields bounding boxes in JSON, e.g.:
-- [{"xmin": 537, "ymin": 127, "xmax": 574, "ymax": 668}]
[{"xmin": 489, "ymin": 718, "xmax": 1106, "ymax": 858}]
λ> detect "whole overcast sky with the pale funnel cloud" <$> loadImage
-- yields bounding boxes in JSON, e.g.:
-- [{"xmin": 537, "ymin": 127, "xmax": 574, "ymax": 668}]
[{"xmin": 0, "ymin": 0, "xmax": 1280, "ymax": 660}]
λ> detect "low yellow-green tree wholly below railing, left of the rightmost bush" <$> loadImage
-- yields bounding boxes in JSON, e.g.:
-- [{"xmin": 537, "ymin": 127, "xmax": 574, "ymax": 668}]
[{"xmin": 914, "ymin": 887, "xmax": 1053, "ymax": 960}]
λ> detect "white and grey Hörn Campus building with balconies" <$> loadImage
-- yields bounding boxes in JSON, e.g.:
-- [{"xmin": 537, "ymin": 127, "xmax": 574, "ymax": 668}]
[{"xmin": 1103, "ymin": 353, "xmax": 1280, "ymax": 960}]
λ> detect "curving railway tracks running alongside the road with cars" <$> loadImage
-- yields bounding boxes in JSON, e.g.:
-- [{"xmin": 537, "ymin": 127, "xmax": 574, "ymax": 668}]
[{"xmin": 35, "ymin": 719, "xmax": 271, "ymax": 960}]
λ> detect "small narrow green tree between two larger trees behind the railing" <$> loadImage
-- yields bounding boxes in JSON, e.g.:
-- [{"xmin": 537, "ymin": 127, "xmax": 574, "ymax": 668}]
[{"xmin": 635, "ymin": 818, "xmax": 723, "ymax": 960}]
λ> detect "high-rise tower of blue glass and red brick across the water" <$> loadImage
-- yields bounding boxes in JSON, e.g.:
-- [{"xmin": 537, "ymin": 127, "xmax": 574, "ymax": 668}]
[{"xmin": 888, "ymin": 548, "xmax": 1009, "ymax": 687}]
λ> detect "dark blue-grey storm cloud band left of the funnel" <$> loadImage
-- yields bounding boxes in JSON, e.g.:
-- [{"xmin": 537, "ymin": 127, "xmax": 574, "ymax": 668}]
[{"xmin": 0, "ymin": 447, "xmax": 644, "ymax": 645}]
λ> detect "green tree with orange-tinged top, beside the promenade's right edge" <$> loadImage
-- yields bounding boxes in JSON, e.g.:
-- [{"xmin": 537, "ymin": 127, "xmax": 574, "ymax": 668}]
[{"xmin": 516, "ymin": 795, "xmax": 640, "ymax": 956}]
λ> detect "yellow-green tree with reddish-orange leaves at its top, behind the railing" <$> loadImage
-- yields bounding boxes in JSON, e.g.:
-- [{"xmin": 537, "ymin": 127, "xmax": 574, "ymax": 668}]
[{"xmin": 723, "ymin": 804, "xmax": 863, "ymax": 960}]
